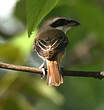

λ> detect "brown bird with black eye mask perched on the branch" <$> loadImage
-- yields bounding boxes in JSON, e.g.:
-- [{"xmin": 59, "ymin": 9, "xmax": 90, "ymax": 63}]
[{"xmin": 34, "ymin": 16, "xmax": 80, "ymax": 86}]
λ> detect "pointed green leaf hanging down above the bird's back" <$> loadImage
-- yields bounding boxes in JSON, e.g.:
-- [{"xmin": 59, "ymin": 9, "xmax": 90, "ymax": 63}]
[{"xmin": 27, "ymin": 0, "xmax": 59, "ymax": 37}]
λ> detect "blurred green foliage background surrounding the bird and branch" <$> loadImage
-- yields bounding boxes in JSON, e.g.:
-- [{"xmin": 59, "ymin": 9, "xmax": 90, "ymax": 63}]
[{"xmin": 0, "ymin": 0, "xmax": 104, "ymax": 110}]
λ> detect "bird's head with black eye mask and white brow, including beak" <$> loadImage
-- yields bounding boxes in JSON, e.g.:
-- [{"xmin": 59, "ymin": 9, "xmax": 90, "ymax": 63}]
[{"xmin": 44, "ymin": 17, "xmax": 80, "ymax": 33}]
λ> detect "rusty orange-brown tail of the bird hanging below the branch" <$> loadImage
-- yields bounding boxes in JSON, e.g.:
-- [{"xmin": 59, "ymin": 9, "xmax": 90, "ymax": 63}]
[{"xmin": 47, "ymin": 61, "xmax": 63, "ymax": 86}]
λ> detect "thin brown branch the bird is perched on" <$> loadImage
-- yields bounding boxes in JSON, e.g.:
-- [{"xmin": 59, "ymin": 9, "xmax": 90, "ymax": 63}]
[{"xmin": 0, "ymin": 62, "xmax": 104, "ymax": 79}]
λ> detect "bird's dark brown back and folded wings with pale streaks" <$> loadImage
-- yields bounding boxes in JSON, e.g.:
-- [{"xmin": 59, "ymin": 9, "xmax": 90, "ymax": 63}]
[{"xmin": 34, "ymin": 31, "xmax": 68, "ymax": 60}]
